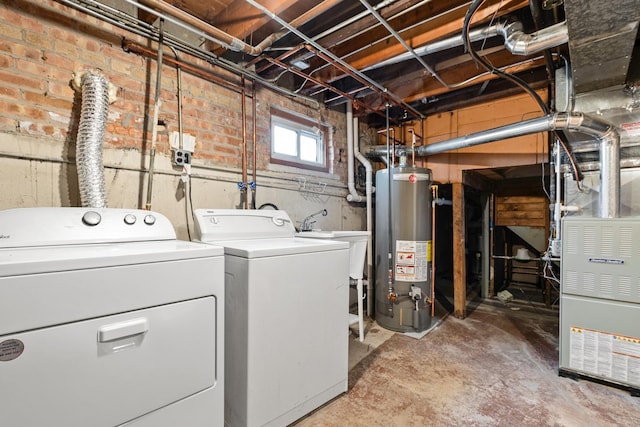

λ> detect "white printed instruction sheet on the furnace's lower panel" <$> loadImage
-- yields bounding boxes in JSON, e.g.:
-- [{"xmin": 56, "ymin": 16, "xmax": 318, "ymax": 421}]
[{"xmin": 569, "ymin": 326, "xmax": 640, "ymax": 385}]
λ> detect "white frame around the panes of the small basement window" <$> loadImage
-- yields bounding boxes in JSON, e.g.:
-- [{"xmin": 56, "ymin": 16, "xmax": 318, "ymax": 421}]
[{"xmin": 269, "ymin": 109, "xmax": 330, "ymax": 172}]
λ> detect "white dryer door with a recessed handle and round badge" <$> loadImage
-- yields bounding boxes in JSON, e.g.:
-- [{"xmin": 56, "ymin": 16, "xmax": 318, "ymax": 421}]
[{"xmin": 0, "ymin": 297, "xmax": 222, "ymax": 427}]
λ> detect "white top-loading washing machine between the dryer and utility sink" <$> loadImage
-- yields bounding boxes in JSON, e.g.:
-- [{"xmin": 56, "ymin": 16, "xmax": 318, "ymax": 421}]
[{"xmin": 195, "ymin": 209, "xmax": 349, "ymax": 427}]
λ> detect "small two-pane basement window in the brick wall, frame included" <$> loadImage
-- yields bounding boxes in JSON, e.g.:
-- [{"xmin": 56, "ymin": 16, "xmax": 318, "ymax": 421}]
[{"xmin": 271, "ymin": 111, "xmax": 328, "ymax": 172}]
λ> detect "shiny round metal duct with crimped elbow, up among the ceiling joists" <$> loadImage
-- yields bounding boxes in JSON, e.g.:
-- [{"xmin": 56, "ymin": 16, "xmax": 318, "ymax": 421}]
[{"xmin": 361, "ymin": 21, "xmax": 569, "ymax": 72}]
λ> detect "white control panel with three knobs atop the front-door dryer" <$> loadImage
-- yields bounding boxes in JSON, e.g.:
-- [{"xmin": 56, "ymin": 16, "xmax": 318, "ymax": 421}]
[{"xmin": 0, "ymin": 207, "xmax": 176, "ymax": 248}]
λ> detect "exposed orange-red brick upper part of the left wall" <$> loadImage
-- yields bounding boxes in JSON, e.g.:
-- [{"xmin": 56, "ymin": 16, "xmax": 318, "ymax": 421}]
[{"xmin": 0, "ymin": 0, "xmax": 345, "ymax": 177}]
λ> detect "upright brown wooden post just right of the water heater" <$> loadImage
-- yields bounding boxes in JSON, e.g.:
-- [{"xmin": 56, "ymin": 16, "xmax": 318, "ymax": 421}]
[{"xmin": 451, "ymin": 183, "xmax": 467, "ymax": 319}]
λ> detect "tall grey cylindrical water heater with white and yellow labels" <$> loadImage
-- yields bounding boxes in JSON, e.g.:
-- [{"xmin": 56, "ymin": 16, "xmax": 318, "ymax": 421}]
[{"xmin": 375, "ymin": 166, "xmax": 432, "ymax": 332}]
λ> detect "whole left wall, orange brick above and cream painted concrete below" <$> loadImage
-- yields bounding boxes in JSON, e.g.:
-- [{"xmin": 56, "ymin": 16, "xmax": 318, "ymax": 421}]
[{"xmin": 0, "ymin": 0, "xmax": 364, "ymax": 238}]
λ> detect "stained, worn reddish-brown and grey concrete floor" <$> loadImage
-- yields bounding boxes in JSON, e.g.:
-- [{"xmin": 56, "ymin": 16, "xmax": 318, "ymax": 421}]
[{"xmin": 295, "ymin": 302, "xmax": 640, "ymax": 427}]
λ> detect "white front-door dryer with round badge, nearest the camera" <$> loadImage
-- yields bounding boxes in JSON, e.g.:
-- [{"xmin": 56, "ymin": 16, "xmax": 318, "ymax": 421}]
[{"xmin": 0, "ymin": 208, "xmax": 224, "ymax": 427}]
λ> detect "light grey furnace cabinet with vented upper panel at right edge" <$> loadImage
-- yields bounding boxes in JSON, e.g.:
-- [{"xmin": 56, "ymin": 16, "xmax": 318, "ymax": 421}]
[{"xmin": 560, "ymin": 217, "xmax": 640, "ymax": 395}]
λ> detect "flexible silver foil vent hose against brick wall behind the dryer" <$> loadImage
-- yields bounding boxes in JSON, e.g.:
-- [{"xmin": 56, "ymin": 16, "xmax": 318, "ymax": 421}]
[{"xmin": 73, "ymin": 70, "xmax": 115, "ymax": 208}]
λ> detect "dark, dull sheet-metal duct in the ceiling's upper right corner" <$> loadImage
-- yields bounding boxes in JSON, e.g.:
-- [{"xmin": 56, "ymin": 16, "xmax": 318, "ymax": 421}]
[{"xmin": 564, "ymin": 0, "xmax": 640, "ymax": 93}]
